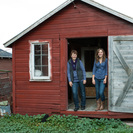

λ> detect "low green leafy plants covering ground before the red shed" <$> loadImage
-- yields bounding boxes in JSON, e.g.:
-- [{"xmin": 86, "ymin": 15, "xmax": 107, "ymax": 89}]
[{"xmin": 0, "ymin": 114, "xmax": 133, "ymax": 133}]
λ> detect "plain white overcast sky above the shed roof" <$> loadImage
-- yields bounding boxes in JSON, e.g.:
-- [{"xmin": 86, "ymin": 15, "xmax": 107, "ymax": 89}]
[{"xmin": 0, "ymin": 0, "xmax": 133, "ymax": 52}]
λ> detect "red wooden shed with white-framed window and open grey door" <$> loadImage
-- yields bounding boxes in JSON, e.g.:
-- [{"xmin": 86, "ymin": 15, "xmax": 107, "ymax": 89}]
[{"xmin": 4, "ymin": 0, "xmax": 133, "ymax": 118}]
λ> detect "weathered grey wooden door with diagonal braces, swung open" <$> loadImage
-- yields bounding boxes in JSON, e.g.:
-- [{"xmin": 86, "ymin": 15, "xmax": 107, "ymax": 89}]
[{"xmin": 108, "ymin": 36, "xmax": 133, "ymax": 113}]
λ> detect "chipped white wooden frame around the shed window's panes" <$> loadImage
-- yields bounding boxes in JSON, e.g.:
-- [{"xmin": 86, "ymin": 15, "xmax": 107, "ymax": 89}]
[{"xmin": 29, "ymin": 40, "xmax": 52, "ymax": 81}]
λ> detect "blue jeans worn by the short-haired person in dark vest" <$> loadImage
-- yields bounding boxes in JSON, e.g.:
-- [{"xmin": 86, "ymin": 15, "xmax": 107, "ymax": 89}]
[{"xmin": 72, "ymin": 81, "xmax": 86, "ymax": 108}]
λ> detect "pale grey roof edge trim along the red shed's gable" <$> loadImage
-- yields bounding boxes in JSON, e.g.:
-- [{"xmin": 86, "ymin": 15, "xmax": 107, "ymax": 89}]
[{"xmin": 4, "ymin": 0, "xmax": 133, "ymax": 47}]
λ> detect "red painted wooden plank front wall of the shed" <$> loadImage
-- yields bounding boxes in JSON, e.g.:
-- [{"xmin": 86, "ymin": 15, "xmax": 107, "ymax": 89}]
[{"xmin": 12, "ymin": 2, "xmax": 133, "ymax": 115}]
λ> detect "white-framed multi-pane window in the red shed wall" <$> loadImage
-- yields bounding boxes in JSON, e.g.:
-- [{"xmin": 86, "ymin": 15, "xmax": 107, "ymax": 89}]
[{"xmin": 30, "ymin": 41, "xmax": 51, "ymax": 81}]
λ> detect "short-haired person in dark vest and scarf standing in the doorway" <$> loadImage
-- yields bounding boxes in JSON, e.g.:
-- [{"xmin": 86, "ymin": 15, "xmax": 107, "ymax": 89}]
[{"xmin": 67, "ymin": 50, "xmax": 86, "ymax": 111}]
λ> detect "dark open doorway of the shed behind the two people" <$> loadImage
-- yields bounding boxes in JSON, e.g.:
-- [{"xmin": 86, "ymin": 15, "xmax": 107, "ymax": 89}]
[{"xmin": 67, "ymin": 37, "xmax": 108, "ymax": 111}]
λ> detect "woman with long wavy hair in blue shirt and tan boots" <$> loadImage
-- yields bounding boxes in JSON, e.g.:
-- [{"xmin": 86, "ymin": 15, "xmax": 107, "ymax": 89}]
[{"xmin": 92, "ymin": 48, "xmax": 108, "ymax": 111}]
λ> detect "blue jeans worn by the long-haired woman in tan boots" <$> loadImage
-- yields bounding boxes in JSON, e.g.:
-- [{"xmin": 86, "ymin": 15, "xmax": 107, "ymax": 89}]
[{"xmin": 95, "ymin": 78, "xmax": 105, "ymax": 101}]
